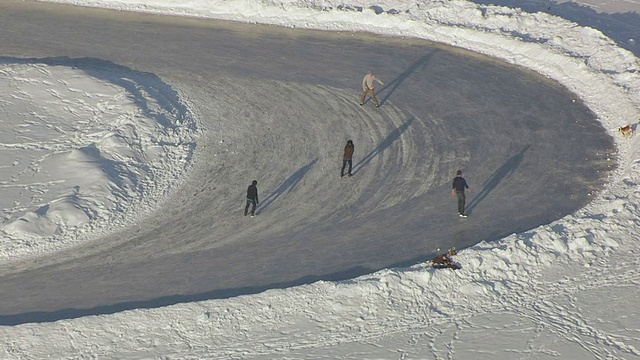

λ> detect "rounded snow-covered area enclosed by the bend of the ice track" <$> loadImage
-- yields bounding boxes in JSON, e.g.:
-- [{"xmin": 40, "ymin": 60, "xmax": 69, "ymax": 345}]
[{"xmin": 0, "ymin": 59, "xmax": 195, "ymax": 258}]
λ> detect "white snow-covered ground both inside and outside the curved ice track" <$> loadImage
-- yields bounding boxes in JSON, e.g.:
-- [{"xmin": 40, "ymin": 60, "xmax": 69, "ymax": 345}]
[{"xmin": 0, "ymin": 0, "xmax": 640, "ymax": 359}]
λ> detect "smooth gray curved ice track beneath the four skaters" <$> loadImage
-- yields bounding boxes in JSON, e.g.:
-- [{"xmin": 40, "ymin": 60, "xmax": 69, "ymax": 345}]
[{"xmin": 0, "ymin": 1, "xmax": 616, "ymax": 324}]
